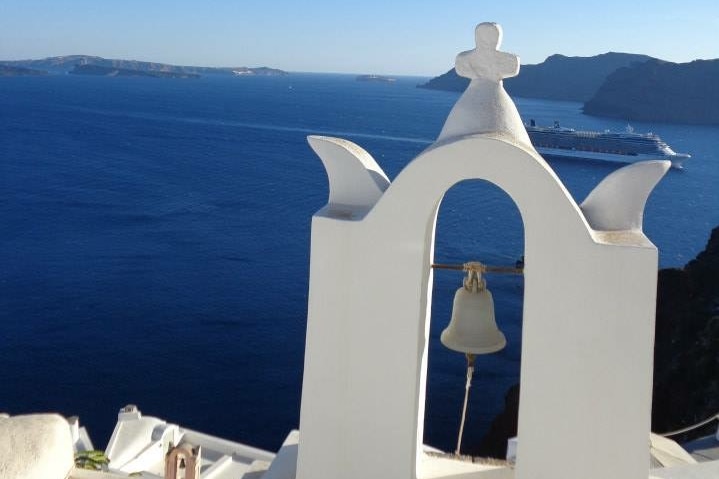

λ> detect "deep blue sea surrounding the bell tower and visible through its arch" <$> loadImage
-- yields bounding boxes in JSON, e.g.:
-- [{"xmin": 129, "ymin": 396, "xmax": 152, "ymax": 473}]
[{"xmin": 0, "ymin": 74, "xmax": 719, "ymax": 450}]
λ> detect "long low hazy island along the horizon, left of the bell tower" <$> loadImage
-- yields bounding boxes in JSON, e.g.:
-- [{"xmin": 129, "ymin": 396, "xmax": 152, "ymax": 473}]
[{"xmin": 0, "ymin": 55, "xmax": 287, "ymax": 78}]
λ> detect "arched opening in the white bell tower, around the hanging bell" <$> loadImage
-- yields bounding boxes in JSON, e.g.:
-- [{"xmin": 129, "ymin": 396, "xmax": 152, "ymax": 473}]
[{"xmin": 424, "ymin": 180, "xmax": 524, "ymax": 459}]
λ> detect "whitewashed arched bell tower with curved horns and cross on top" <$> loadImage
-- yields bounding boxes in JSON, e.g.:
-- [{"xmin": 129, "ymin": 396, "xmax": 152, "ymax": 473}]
[{"xmin": 297, "ymin": 23, "xmax": 669, "ymax": 479}]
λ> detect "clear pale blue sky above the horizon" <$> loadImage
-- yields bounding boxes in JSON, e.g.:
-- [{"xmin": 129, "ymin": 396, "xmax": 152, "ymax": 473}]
[{"xmin": 0, "ymin": 0, "xmax": 719, "ymax": 75}]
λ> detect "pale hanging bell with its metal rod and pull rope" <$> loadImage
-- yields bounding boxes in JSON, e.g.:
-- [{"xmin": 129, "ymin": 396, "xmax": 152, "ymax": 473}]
[{"xmin": 432, "ymin": 262, "xmax": 521, "ymax": 456}]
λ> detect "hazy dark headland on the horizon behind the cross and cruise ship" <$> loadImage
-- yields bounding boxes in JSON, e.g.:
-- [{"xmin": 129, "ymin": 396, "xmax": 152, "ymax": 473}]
[{"xmin": 418, "ymin": 52, "xmax": 719, "ymax": 124}]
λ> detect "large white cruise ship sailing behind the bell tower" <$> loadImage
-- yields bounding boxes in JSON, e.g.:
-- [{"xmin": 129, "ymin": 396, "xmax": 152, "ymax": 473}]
[{"xmin": 524, "ymin": 120, "xmax": 690, "ymax": 168}]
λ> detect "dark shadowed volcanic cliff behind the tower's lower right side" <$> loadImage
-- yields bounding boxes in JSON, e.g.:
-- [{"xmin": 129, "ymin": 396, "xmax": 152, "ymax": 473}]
[{"xmin": 472, "ymin": 226, "xmax": 719, "ymax": 458}]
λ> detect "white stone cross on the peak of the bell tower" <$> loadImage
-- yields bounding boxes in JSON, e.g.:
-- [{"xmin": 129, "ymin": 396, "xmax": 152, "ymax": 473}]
[{"xmin": 455, "ymin": 22, "xmax": 519, "ymax": 82}]
